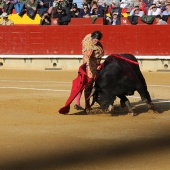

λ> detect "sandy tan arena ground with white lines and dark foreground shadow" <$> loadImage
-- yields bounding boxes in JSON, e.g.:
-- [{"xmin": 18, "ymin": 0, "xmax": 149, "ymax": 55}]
[{"xmin": 0, "ymin": 70, "xmax": 170, "ymax": 170}]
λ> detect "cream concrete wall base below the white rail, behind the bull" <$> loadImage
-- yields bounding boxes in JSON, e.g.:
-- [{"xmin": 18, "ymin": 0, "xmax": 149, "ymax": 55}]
[{"xmin": 0, "ymin": 57, "xmax": 170, "ymax": 71}]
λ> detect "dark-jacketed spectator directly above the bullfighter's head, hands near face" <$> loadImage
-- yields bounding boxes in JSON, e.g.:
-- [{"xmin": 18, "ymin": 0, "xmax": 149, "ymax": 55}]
[{"xmin": 90, "ymin": 2, "xmax": 104, "ymax": 18}]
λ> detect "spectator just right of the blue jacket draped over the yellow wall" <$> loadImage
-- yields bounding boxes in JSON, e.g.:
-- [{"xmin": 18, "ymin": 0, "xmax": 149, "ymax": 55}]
[{"xmin": 25, "ymin": 0, "xmax": 38, "ymax": 19}]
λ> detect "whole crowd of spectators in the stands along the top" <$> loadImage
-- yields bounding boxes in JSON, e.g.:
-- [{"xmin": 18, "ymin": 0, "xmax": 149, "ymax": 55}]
[{"xmin": 0, "ymin": 0, "xmax": 170, "ymax": 25}]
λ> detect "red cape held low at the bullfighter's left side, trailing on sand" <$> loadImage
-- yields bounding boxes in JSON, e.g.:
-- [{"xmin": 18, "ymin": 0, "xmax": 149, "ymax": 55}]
[{"xmin": 58, "ymin": 64, "xmax": 89, "ymax": 114}]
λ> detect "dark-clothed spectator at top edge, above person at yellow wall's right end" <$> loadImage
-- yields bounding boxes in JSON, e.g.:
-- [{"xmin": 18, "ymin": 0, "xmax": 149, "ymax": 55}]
[{"xmin": 37, "ymin": 0, "xmax": 52, "ymax": 17}]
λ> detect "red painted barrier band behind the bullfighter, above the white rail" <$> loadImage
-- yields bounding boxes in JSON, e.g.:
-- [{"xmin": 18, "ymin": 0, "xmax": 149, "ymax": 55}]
[{"xmin": 0, "ymin": 24, "xmax": 170, "ymax": 56}]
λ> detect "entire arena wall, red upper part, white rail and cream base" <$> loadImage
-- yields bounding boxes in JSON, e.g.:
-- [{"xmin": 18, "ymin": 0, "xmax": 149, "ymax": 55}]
[{"xmin": 0, "ymin": 25, "xmax": 170, "ymax": 71}]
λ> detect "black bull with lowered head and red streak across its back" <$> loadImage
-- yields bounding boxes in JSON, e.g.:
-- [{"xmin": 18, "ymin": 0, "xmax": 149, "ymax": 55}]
[{"xmin": 89, "ymin": 54, "xmax": 154, "ymax": 112}]
